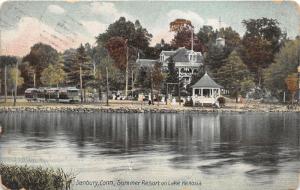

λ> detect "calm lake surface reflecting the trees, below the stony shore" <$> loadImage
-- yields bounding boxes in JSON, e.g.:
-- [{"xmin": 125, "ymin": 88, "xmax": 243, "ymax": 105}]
[{"xmin": 0, "ymin": 113, "xmax": 300, "ymax": 190}]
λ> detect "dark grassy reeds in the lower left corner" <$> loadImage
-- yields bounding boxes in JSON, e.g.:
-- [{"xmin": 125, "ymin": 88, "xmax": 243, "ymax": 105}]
[{"xmin": 0, "ymin": 163, "xmax": 75, "ymax": 190}]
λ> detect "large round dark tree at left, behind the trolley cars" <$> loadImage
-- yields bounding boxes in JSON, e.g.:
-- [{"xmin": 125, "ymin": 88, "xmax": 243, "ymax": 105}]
[{"xmin": 22, "ymin": 43, "xmax": 58, "ymax": 86}]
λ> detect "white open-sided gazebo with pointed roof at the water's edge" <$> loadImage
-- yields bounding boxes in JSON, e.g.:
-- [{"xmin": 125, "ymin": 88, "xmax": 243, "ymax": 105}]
[{"xmin": 192, "ymin": 73, "xmax": 223, "ymax": 106}]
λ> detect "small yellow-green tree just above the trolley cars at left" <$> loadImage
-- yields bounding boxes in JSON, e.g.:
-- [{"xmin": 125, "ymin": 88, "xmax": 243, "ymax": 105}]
[{"xmin": 41, "ymin": 58, "xmax": 66, "ymax": 86}]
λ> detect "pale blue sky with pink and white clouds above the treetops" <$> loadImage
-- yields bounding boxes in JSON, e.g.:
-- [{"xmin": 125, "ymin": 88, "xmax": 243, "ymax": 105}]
[{"xmin": 0, "ymin": 0, "xmax": 300, "ymax": 56}]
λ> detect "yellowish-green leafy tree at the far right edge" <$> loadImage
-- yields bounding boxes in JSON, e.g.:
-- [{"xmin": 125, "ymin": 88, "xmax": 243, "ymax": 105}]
[{"xmin": 263, "ymin": 39, "xmax": 300, "ymax": 98}]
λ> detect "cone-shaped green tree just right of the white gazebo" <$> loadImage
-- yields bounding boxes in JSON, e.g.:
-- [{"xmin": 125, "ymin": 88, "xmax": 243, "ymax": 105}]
[{"xmin": 217, "ymin": 51, "xmax": 254, "ymax": 101}]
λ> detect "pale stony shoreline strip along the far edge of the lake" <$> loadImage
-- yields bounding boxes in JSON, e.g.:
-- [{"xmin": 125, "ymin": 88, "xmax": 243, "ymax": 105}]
[{"xmin": 0, "ymin": 104, "xmax": 300, "ymax": 113}]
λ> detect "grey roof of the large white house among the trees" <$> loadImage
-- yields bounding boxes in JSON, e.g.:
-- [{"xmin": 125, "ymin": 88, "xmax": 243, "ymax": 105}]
[{"xmin": 161, "ymin": 47, "xmax": 203, "ymax": 63}]
